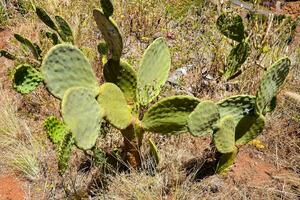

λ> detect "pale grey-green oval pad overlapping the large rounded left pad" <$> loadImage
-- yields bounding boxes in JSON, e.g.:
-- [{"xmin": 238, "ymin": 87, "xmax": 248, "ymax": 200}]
[{"xmin": 62, "ymin": 87, "xmax": 102, "ymax": 150}]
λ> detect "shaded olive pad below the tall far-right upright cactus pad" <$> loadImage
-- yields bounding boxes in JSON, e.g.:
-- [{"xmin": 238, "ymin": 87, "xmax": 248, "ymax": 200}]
[{"xmin": 235, "ymin": 115, "xmax": 265, "ymax": 145}]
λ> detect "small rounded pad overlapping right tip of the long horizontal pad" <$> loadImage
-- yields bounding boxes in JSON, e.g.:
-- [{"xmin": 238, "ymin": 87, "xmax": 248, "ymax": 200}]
[{"xmin": 188, "ymin": 101, "xmax": 220, "ymax": 136}]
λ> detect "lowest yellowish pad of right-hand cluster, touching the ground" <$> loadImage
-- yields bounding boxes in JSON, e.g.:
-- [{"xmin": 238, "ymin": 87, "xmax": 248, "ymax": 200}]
[{"xmin": 216, "ymin": 147, "xmax": 238, "ymax": 174}]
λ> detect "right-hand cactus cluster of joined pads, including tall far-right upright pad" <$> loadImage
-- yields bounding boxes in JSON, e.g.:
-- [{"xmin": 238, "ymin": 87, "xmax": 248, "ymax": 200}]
[{"xmin": 188, "ymin": 58, "xmax": 291, "ymax": 173}]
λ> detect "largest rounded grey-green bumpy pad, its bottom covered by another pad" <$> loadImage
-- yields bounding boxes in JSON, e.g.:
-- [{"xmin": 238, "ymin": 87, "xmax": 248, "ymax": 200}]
[{"xmin": 42, "ymin": 44, "xmax": 98, "ymax": 99}]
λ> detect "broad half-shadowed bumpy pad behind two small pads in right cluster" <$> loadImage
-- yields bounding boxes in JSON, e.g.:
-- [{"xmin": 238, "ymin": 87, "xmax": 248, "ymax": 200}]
[{"xmin": 218, "ymin": 95, "xmax": 255, "ymax": 125}]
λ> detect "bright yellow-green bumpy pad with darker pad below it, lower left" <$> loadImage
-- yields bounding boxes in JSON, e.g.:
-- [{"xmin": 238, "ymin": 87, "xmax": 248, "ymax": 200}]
[{"xmin": 44, "ymin": 116, "xmax": 74, "ymax": 174}]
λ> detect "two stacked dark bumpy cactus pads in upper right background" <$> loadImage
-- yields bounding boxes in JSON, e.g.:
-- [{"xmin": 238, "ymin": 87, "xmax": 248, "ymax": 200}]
[{"xmin": 217, "ymin": 13, "xmax": 250, "ymax": 80}]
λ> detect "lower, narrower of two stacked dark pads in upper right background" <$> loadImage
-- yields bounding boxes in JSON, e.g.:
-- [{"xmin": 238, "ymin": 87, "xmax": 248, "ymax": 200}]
[{"xmin": 224, "ymin": 42, "xmax": 250, "ymax": 80}]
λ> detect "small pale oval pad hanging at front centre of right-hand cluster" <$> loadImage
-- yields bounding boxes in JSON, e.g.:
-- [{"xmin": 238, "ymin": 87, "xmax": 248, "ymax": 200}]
[{"xmin": 214, "ymin": 115, "xmax": 235, "ymax": 153}]
